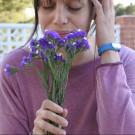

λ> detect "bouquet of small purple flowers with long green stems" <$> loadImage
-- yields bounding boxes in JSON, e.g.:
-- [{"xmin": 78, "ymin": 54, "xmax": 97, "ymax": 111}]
[{"xmin": 5, "ymin": 29, "xmax": 90, "ymax": 134}]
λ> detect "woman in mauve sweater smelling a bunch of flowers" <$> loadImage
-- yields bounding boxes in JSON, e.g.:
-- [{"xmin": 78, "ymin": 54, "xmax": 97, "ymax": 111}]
[{"xmin": 0, "ymin": 0, "xmax": 135, "ymax": 134}]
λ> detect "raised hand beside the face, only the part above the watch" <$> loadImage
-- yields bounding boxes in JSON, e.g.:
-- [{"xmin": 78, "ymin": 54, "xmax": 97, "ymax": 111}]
[{"xmin": 91, "ymin": 0, "xmax": 115, "ymax": 47}]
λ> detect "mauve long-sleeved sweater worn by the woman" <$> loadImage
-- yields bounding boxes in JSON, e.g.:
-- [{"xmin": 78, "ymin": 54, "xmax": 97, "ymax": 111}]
[{"xmin": 0, "ymin": 47, "xmax": 135, "ymax": 135}]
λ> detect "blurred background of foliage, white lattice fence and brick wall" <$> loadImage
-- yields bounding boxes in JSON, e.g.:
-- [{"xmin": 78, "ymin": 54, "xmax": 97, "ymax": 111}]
[{"xmin": 0, "ymin": 0, "xmax": 135, "ymax": 60}]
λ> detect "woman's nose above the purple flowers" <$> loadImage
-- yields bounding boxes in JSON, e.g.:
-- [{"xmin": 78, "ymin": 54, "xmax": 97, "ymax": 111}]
[{"xmin": 53, "ymin": 6, "xmax": 68, "ymax": 25}]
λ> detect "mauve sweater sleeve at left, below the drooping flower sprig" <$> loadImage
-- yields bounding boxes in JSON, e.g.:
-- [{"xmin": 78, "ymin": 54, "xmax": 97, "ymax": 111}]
[{"xmin": 0, "ymin": 59, "xmax": 29, "ymax": 135}]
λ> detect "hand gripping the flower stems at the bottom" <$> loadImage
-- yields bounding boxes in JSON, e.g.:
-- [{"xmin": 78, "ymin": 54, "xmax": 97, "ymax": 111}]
[{"xmin": 33, "ymin": 100, "xmax": 68, "ymax": 135}]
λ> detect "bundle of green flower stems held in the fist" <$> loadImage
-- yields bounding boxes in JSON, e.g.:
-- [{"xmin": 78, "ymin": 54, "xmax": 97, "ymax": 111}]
[{"xmin": 44, "ymin": 60, "xmax": 71, "ymax": 135}]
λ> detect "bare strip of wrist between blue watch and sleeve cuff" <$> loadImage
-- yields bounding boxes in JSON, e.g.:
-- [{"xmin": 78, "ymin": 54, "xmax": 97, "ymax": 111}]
[{"xmin": 100, "ymin": 50, "xmax": 120, "ymax": 64}]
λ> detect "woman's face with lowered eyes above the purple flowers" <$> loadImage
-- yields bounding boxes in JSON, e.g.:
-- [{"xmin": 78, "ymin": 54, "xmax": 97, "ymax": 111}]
[{"xmin": 38, "ymin": 0, "xmax": 91, "ymax": 36}]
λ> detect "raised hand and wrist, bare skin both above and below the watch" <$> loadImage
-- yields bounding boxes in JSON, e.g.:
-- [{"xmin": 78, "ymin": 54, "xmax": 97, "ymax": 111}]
[{"xmin": 91, "ymin": 0, "xmax": 120, "ymax": 64}]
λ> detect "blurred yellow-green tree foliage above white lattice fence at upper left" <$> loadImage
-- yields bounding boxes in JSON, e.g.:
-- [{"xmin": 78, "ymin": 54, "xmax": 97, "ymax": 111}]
[{"xmin": 0, "ymin": 0, "xmax": 32, "ymax": 23}]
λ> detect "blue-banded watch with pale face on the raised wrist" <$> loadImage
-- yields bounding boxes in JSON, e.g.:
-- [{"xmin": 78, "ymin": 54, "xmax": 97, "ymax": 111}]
[{"xmin": 98, "ymin": 43, "xmax": 121, "ymax": 56}]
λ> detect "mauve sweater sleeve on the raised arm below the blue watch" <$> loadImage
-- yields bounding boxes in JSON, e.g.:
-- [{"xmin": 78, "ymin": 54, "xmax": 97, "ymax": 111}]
[{"xmin": 96, "ymin": 58, "xmax": 135, "ymax": 134}]
